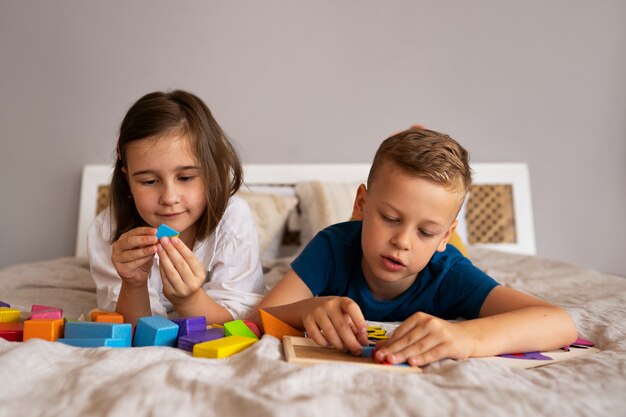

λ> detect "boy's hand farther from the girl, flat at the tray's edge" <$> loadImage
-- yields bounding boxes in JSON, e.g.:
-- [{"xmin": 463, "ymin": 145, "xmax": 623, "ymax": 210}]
[{"xmin": 375, "ymin": 313, "xmax": 476, "ymax": 366}]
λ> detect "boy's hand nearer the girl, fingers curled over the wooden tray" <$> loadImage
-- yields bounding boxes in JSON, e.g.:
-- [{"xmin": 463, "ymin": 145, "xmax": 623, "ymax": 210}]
[{"xmin": 302, "ymin": 297, "xmax": 368, "ymax": 355}]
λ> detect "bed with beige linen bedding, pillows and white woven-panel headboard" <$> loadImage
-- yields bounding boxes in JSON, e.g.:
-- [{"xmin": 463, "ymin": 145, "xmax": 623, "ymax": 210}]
[{"xmin": 0, "ymin": 164, "xmax": 626, "ymax": 416}]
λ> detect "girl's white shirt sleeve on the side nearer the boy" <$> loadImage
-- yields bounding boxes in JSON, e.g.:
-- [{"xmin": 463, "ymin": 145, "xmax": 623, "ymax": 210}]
[{"xmin": 202, "ymin": 196, "xmax": 265, "ymax": 319}]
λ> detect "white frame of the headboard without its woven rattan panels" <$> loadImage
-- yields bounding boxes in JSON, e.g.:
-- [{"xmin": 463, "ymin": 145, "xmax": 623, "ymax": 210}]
[{"xmin": 75, "ymin": 163, "xmax": 536, "ymax": 257}]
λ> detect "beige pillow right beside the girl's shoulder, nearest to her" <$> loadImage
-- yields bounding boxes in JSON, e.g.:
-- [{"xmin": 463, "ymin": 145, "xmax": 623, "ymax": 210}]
[{"xmin": 237, "ymin": 190, "xmax": 298, "ymax": 258}]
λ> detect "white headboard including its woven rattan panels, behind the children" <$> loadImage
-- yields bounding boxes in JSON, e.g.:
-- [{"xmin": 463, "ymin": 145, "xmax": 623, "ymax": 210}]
[{"xmin": 76, "ymin": 163, "xmax": 535, "ymax": 256}]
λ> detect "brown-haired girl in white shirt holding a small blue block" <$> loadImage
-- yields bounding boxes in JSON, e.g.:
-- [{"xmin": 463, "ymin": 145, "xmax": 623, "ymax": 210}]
[{"xmin": 88, "ymin": 90, "xmax": 264, "ymax": 324}]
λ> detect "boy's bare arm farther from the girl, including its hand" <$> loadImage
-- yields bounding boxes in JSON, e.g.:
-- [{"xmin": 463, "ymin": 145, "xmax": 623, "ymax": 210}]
[{"xmin": 377, "ymin": 286, "xmax": 577, "ymax": 366}]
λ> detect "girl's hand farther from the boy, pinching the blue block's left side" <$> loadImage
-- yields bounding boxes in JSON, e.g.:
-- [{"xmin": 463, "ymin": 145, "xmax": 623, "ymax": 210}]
[{"xmin": 111, "ymin": 227, "xmax": 157, "ymax": 288}]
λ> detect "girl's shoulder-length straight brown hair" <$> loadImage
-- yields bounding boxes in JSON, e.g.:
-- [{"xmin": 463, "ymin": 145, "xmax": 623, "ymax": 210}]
[{"xmin": 109, "ymin": 90, "xmax": 243, "ymax": 242}]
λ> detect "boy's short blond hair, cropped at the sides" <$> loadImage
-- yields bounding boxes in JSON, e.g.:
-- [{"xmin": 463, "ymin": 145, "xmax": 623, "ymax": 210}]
[{"xmin": 367, "ymin": 127, "xmax": 472, "ymax": 199}]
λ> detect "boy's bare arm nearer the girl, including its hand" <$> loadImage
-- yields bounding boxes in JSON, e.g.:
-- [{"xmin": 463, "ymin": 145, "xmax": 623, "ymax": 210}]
[{"xmin": 248, "ymin": 270, "xmax": 367, "ymax": 354}]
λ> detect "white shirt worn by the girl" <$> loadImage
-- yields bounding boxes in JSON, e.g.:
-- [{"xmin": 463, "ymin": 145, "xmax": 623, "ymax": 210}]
[{"xmin": 87, "ymin": 196, "xmax": 265, "ymax": 319}]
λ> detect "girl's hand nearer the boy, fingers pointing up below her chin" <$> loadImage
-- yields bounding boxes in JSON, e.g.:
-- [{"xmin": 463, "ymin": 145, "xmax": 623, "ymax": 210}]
[{"xmin": 158, "ymin": 237, "xmax": 207, "ymax": 307}]
